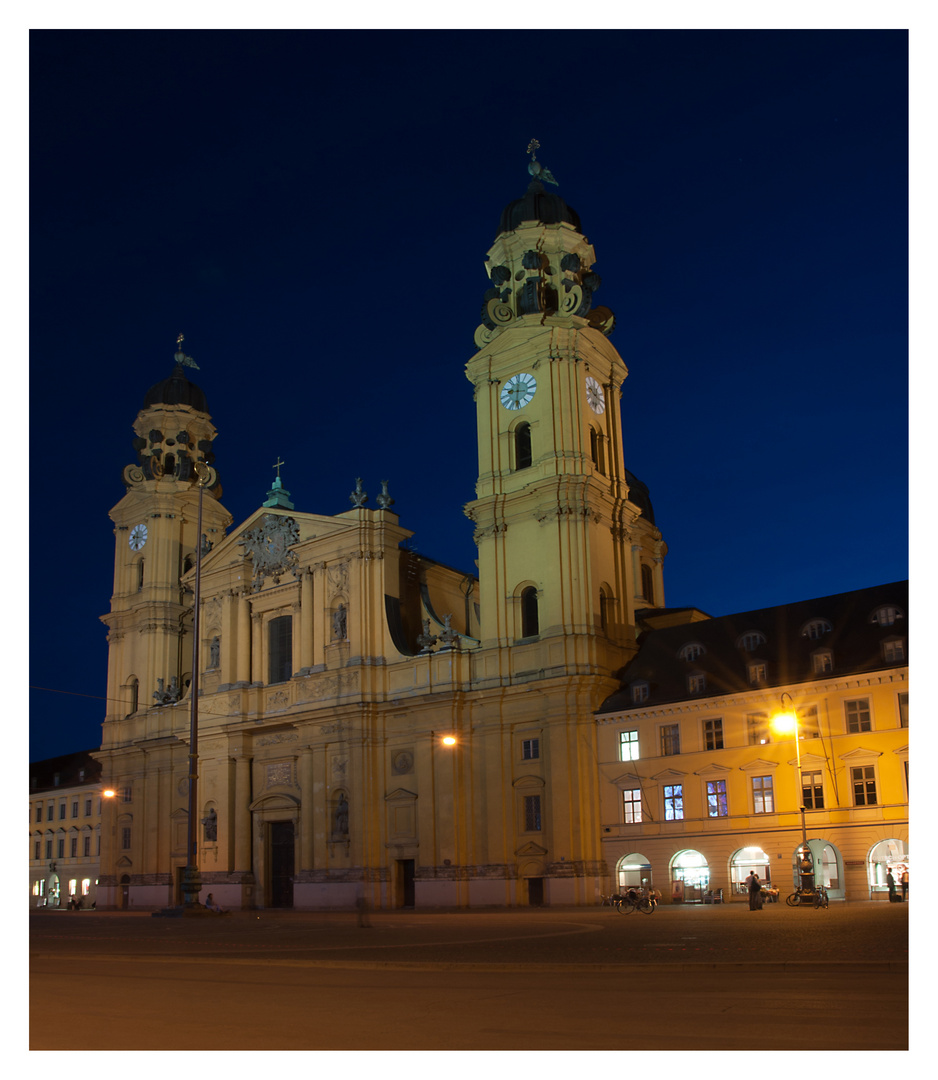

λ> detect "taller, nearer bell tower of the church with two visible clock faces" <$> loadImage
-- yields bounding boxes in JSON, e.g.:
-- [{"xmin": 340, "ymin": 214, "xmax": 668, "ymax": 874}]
[{"xmin": 465, "ymin": 140, "xmax": 666, "ymax": 673}]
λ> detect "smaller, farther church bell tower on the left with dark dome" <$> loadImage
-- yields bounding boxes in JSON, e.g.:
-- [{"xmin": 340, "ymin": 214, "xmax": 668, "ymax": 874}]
[{"xmin": 101, "ymin": 334, "xmax": 231, "ymax": 745}]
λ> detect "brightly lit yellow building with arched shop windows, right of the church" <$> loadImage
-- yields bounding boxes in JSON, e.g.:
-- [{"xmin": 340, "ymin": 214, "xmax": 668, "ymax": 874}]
[{"xmin": 596, "ymin": 581, "xmax": 909, "ymax": 902}]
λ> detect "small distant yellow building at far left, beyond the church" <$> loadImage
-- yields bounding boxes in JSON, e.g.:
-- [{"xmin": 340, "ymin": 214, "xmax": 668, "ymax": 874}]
[{"xmin": 29, "ymin": 751, "xmax": 101, "ymax": 908}]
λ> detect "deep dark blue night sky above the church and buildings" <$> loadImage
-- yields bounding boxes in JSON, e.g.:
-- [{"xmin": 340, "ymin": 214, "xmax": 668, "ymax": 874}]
[{"xmin": 29, "ymin": 30, "xmax": 908, "ymax": 759}]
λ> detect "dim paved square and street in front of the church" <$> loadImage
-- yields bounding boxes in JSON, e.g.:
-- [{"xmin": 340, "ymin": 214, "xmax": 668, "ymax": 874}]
[{"xmin": 29, "ymin": 903, "xmax": 909, "ymax": 1050}]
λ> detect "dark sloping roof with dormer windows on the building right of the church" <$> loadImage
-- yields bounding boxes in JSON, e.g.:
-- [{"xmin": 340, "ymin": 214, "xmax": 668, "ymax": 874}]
[{"xmin": 597, "ymin": 581, "xmax": 909, "ymax": 714}]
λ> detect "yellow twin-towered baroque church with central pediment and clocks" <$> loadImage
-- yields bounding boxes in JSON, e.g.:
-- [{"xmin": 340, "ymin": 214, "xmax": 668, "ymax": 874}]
[{"xmin": 95, "ymin": 161, "xmax": 664, "ymax": 909}]
